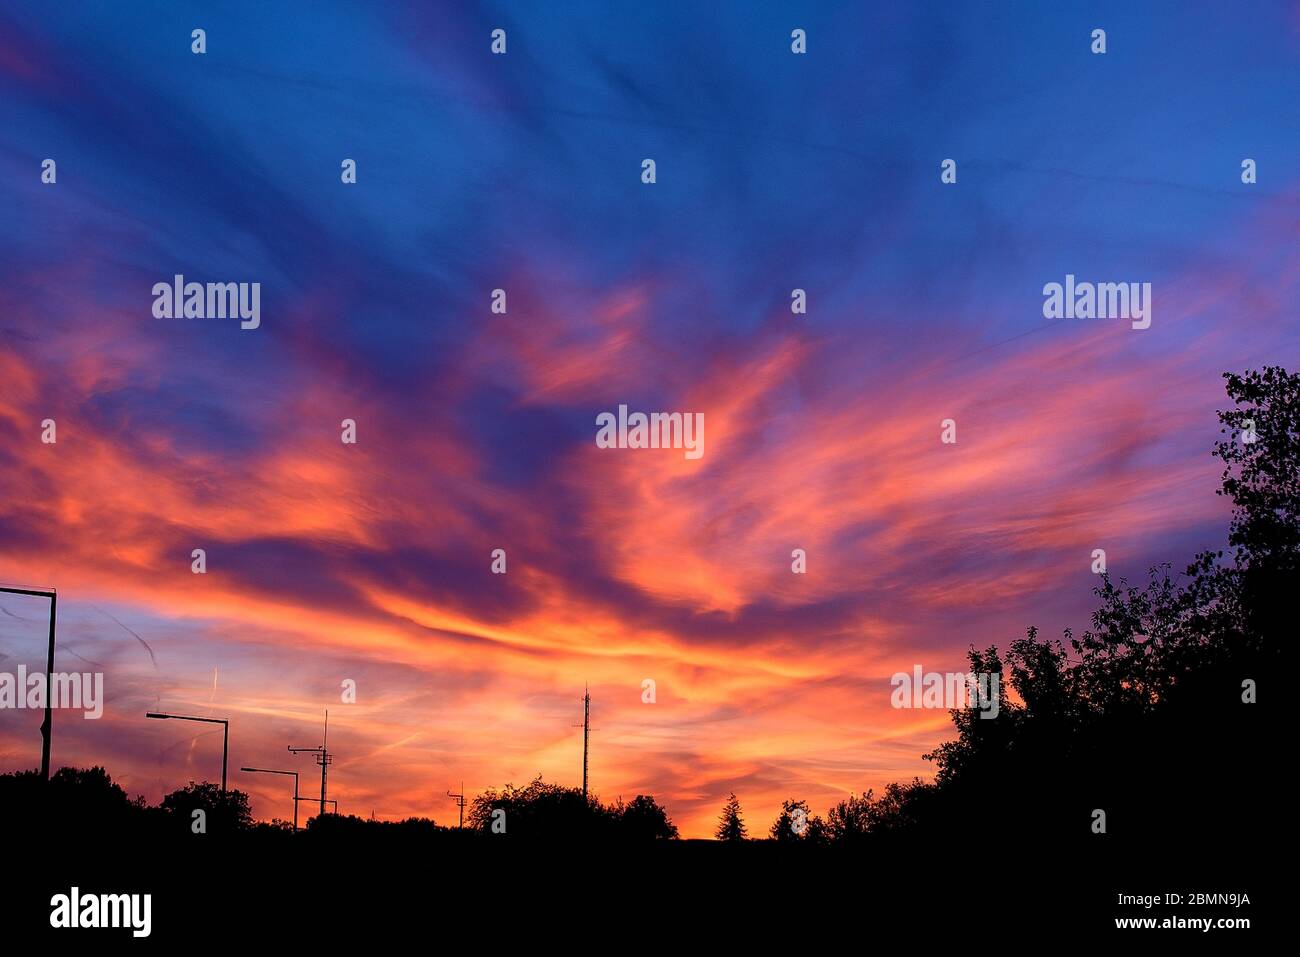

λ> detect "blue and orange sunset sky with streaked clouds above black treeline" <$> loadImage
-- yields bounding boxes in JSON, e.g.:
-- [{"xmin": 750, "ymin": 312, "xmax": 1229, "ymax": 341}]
[{"xmin": 0, "ymin": 0, "xmax": 1300, "ymax": 836}]
